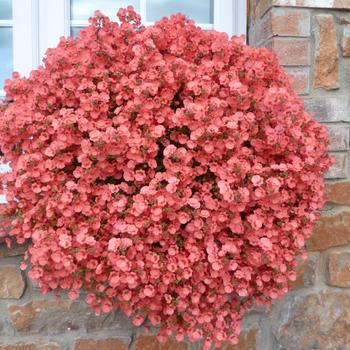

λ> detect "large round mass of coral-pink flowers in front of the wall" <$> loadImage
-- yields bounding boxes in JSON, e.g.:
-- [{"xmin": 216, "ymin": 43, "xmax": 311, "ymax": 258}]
[{"xmin": 0, "ymin": 7, "xmax": 331, "ymax": 348}]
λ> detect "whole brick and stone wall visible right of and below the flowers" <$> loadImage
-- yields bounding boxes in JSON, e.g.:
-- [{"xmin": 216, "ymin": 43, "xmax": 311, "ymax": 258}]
[{"xmin": 0, "ymin": 0, "xmax": 350, "ymax": 350}]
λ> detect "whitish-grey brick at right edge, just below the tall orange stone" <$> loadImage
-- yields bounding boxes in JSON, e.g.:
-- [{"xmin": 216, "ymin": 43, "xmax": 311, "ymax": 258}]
[{"xmin": 304, "ymin": 95, "xmax": 350, "ymax": 123}]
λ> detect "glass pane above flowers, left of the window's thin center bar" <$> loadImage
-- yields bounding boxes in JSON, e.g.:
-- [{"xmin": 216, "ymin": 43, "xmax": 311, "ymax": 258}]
[{"xmin": 71, "ymin": 0, "xmax": 140, "ymax": 20}]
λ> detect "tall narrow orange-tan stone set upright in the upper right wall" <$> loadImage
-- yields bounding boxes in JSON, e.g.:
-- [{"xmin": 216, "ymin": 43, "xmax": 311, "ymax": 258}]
[{"xmin": 314, "ymin": 14, "xmax": 339, "ymax": 90}]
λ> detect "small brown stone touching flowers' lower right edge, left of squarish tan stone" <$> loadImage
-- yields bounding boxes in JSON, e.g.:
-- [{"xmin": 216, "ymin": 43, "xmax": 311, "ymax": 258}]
[{"xmin": 290, "ymin": 253, "xmax": 318, "ymax": 290}]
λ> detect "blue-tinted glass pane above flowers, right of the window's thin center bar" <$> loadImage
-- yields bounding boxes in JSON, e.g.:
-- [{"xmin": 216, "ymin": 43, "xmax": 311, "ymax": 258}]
[{"xmin": 146, "ymin": 0, "xmax": 213, "ymax": 23}]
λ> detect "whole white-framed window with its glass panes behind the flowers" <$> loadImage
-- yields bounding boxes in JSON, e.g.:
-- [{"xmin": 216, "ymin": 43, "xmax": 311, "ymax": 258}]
[{"xmin": 0, "ymin": 0, "xmax": 246, "ymax": 97}]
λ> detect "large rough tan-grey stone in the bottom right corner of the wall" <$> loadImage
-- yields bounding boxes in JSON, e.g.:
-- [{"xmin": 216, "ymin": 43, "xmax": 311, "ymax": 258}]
[{"xmin": 274, "ymin": 293, "xmax": 350, "ymax": 350}]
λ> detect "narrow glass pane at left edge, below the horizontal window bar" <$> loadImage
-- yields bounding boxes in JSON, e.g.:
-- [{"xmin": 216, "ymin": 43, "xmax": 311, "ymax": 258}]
[{"xmin": 0, "ymin": 27, "xmax": 13, "ymax": 90}]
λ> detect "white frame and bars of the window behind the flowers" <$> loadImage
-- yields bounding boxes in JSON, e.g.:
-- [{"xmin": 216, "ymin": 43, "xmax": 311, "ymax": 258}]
[{"xmin": 0, "ymin": 0, "xmax": 247, "ymax": 97}]
